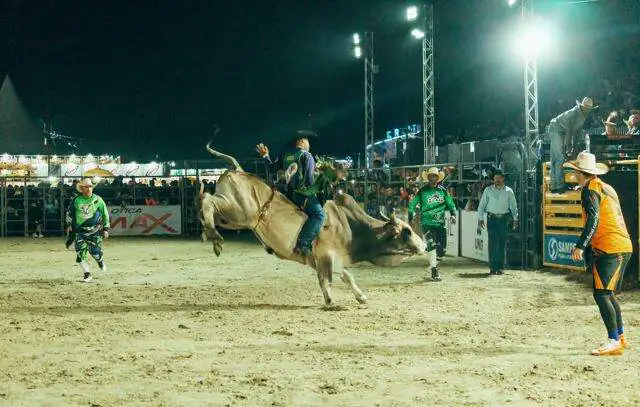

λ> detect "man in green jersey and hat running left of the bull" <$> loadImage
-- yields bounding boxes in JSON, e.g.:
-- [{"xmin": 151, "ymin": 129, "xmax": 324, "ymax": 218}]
[{"xmin": 66, "ymin": 179, "xmax": 110, "ymax": 283}]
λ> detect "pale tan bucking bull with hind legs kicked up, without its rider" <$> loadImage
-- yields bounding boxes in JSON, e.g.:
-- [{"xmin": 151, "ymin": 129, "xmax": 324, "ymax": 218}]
[{"xmin": 200, "ymin": 144, "xmax": 425, "ymax": 306}]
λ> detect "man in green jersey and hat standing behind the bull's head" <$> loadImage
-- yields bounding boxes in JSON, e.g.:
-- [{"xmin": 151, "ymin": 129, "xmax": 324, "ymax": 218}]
[{"xmin": 408, "ymin": 167, "xmax": 457, "ymax": 281}]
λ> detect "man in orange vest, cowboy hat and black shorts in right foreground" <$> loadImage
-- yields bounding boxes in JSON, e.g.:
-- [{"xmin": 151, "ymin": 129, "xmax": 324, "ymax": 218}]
[{"xmin": 564, "ymin": 151, "xmax": 633, "ymax": 356}]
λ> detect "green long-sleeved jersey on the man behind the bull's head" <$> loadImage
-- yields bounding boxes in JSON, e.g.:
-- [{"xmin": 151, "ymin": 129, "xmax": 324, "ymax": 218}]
[{"xmin": 408, "ymin": 185, "xmax": 457, "ymax": 227}]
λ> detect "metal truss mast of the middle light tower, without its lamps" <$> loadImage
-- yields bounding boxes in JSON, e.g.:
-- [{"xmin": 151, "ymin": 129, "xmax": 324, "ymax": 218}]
[{"xmin": 422, "ymin": 4, "xmax": 436, "ymax": 164}]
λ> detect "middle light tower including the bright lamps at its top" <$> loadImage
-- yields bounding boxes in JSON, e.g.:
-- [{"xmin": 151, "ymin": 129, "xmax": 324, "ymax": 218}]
[{"xmin": 407, "ymin": 4, "xmax": 436, "ymax": 164}]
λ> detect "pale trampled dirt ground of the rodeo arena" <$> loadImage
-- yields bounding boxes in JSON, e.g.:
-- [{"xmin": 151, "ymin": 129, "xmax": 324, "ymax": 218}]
[{"xmin": 0, "ymin": 235, "xmax": 640, "ymax": 407}]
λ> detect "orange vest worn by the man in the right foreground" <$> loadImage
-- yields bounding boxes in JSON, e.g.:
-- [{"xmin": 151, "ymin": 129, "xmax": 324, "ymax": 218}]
[{"xmin": 582, "ymin": 178, "xmax": 633, "ymax": 253}]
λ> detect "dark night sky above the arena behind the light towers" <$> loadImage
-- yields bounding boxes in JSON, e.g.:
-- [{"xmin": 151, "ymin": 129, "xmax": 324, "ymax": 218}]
[{"xmin": 0, "ymin": 0, "xmax": 640, "ymax": 160}]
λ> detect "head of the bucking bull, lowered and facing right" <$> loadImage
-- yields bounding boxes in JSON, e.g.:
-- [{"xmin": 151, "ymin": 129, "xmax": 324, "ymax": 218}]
[{"xmin": 372, "ymin": 213, "xmax": 426, "ymax": 266}]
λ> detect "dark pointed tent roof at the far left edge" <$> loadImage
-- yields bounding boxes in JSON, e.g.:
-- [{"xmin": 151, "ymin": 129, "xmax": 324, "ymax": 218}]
[{"xmin": 0, "ymin": 75, "xmax": 44, "ymax": 154}]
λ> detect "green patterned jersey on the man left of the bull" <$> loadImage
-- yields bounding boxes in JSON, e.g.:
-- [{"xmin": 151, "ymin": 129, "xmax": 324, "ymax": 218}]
[{"xmin": 66, "ymin": 194, "xmax": 110, "ymax": 233}]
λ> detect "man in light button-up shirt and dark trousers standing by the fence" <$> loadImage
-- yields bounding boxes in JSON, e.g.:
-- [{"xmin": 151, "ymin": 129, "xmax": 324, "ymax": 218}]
[{"xmin": 478, "ymin": 170, "xmax": 518, "ymax": 276}]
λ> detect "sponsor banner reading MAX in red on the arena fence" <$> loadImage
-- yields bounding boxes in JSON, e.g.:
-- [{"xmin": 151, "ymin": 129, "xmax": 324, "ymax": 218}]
[{"xmin": 108, "ymin": 205, "xmax": 182, "ymax": 236}]
